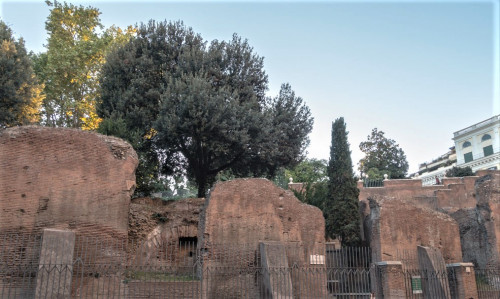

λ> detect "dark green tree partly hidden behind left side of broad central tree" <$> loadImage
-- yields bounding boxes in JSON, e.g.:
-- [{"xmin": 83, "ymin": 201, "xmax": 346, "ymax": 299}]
[{"xmin": 97, "ymin": 21, "xmax": 205, "ymax": 195}]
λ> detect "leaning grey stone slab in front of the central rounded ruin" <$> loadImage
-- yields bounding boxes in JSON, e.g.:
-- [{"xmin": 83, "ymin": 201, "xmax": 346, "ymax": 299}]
[{"xmin": 259, "ymin": 242, "xmax": 293, "ymax": 299}]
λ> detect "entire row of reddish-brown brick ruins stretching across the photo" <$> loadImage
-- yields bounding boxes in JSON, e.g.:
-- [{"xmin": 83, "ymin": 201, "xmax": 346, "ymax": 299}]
[{"xmin": 0, "ymin": 127, "xmax": 500, "ymax": 298}]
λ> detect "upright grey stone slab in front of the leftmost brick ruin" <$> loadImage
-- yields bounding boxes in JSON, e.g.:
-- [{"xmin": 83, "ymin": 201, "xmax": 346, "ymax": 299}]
[{"xmin": 35, "ymin": 229, "xmax": 75, "ymax": 299}]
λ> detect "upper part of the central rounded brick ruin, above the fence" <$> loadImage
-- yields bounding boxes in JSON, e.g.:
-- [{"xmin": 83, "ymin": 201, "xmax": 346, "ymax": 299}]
[{"xmin": 200, "ymin": 179, "xmax": 325, "ymax": 251}]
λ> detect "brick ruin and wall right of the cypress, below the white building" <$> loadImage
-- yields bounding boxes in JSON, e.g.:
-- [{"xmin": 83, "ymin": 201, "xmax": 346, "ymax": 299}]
[{"xmin": 358, "ymin": 171, "xmax": 500, "ymax": 269}]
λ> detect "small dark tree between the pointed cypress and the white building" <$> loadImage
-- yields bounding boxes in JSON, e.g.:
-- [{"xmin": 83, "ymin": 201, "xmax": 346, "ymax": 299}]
[{"xmin": 359, "ymin": 128, "xmax": 408, "ymax": 179}]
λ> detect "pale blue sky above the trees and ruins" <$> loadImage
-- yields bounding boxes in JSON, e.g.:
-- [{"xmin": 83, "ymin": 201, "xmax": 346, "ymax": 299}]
[{"xmin": 0, "ymin": 0, "xmax": 500, "ymax": 172}]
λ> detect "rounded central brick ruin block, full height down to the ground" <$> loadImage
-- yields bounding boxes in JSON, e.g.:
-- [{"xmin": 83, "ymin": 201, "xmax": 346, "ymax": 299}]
[{"xmin": 198, "ymin": 179, "xmax": 326, "ymax": 298}]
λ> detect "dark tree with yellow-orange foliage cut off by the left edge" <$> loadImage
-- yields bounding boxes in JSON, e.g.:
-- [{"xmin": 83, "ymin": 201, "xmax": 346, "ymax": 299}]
[{"xmin": 0, "ymin": 20, "xmax": 43, "ymax": 128}]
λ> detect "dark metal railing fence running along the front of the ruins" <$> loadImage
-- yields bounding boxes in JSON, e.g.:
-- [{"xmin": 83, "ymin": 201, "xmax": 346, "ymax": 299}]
[{"xmin": 0, "ymin": 235, "xmax": 500, "ymax": 299}]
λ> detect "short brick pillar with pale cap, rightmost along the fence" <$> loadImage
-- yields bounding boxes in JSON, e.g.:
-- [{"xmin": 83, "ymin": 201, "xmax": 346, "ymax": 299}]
[{"xmin": 446, "ymin": 263, "xmax": 478, "ymax": 299}]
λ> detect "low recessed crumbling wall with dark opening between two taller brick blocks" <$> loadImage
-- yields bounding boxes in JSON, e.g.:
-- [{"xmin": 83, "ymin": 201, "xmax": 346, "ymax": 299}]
[{"xmin": 129, "ymin": 198, "xmax": 205, "ymax": 268}]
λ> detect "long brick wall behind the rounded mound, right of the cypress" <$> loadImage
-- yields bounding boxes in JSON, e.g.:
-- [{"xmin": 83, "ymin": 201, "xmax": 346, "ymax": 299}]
[{"xmin": 358, "ymin": 170, "xmax": 500, "ymax": 268}]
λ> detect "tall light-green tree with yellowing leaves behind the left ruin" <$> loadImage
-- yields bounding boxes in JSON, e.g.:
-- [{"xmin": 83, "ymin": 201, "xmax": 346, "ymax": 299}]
[{"xmin": 37, "ymin": 1, "xmax": 134, "ymax": 130}]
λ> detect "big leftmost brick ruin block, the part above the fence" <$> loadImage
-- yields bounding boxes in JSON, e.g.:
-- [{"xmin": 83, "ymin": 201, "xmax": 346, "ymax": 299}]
[{"xmin": 0, "ymin": 126, "xmax": 138, "ymax": 239}]
